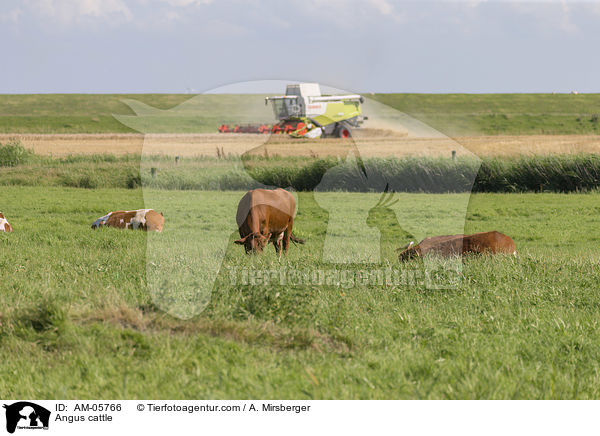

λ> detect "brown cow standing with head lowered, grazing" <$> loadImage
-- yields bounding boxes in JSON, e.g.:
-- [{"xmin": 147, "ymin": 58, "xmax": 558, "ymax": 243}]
[{"xmin": 234, "ymin": 189, "xmax": 304, "ymax": 256}]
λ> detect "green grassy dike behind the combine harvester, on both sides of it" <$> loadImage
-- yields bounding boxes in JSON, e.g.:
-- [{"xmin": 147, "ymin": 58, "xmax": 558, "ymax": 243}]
[{"xmin": 0, "ymin": 94, "xmax": 600, "ymax": 136}]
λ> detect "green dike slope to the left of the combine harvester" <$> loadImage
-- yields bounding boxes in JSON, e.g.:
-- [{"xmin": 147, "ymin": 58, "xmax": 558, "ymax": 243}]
[{"xmin": 0, "ymin": 94, "xmax": 272, "ymax": 134}]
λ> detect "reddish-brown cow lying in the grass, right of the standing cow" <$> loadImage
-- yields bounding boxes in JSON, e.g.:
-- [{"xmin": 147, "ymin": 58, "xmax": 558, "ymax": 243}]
[{"xmin": 398, "ymin": 231, "xmax": 517, "ymax": 261}]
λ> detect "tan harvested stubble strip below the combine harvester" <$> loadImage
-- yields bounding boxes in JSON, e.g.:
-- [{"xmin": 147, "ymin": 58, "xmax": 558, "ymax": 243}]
[{"xmin": 0, "ymin": 135, "xmax": 600, "ymax": 157}]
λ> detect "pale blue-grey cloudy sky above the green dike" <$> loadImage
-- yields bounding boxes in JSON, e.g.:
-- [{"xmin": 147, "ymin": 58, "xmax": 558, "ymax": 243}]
[{"xmin": 0, "ymin": 0, "xmax": 600, "ymax": 93}]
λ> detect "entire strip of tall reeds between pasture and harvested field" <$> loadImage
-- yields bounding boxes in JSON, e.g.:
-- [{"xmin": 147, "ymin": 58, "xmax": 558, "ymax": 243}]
[{"xmin": 0, "ymin": 142, "xmax": 600, "ymax": 193}]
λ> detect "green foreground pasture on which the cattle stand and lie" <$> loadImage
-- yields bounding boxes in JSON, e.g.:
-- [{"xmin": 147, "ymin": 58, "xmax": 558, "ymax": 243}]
[{"xmin": 0, "ymin": 186, "xmax": 600, "ymax": 399}]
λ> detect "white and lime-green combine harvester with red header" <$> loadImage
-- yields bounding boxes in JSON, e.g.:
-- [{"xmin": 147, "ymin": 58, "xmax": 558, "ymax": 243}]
[{"xmin": 219, "ymin": 83, "xmax": 367, "ymax": 138}]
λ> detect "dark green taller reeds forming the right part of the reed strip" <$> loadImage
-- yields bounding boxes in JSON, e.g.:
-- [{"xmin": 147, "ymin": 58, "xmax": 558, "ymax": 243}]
[{"xmin": 249, "ymin": 154, "xmax": 600, "ymax": 192}]
